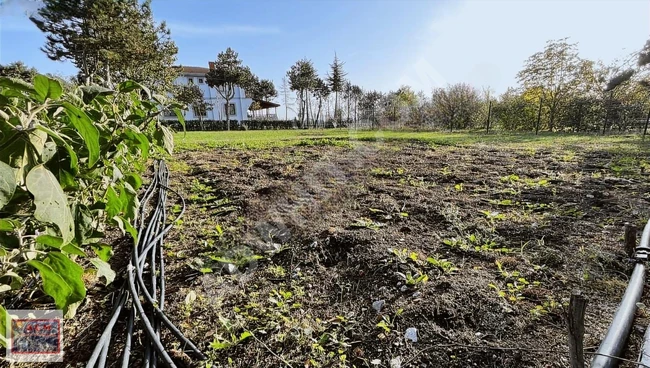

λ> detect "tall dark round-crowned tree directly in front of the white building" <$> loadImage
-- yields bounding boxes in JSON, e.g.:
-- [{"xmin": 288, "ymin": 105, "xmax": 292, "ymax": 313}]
[{"xmin": 205, "ymin": 47, "xmax": 255, "ymax": 130}]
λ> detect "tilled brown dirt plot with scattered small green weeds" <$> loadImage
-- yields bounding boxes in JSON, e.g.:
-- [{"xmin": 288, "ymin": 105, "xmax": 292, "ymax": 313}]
[{"xmin": 11, "ymin": 136, "xmax": 650, "ymax": 368}]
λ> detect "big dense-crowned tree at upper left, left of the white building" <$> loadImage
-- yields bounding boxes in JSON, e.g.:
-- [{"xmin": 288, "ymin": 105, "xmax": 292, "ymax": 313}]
[{"xmin": 30, "ymin": 0, "xmax": 178, "ymax": 91}]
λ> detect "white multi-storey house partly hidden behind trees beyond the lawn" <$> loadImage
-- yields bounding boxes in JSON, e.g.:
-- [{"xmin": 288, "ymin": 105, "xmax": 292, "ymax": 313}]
[{"xmin": 165, "ymin": 66, "xmax": 280, "ymax": 121}]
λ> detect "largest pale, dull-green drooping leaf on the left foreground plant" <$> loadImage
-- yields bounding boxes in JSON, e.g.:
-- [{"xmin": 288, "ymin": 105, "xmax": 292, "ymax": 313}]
[{"xmin": 26, "ymin": 165, "xmax": 74, "ymax": 244}]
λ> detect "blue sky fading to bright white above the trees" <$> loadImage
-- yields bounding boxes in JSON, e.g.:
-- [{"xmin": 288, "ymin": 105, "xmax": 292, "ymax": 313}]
[{"xmin": 0, "ymin": 0, "xmax": 650, "ymax": 100}]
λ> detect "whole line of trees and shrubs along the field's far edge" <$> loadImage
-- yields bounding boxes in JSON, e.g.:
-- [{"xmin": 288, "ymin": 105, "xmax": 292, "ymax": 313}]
[{"xmin": 0, "ymin": 0, "xmax": 650, "ymax": 133}]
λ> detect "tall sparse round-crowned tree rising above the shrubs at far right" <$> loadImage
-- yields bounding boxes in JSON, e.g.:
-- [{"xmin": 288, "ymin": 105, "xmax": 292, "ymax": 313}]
[{"xmin": 517, "ymin": 38, "xmax": 581, "ymax": 130}]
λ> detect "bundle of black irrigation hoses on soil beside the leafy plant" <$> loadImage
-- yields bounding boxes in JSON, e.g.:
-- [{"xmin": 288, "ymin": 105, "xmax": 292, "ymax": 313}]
[{"xmin": 86, "ymin": 161, "xmax": 206, "ymax": 368}]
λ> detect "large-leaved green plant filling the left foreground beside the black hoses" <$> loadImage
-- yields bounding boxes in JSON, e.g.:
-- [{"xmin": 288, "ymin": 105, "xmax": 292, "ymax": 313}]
[{"xmin": 0, "ymin": 75, "xmax": 183, "ymax": 332}]
